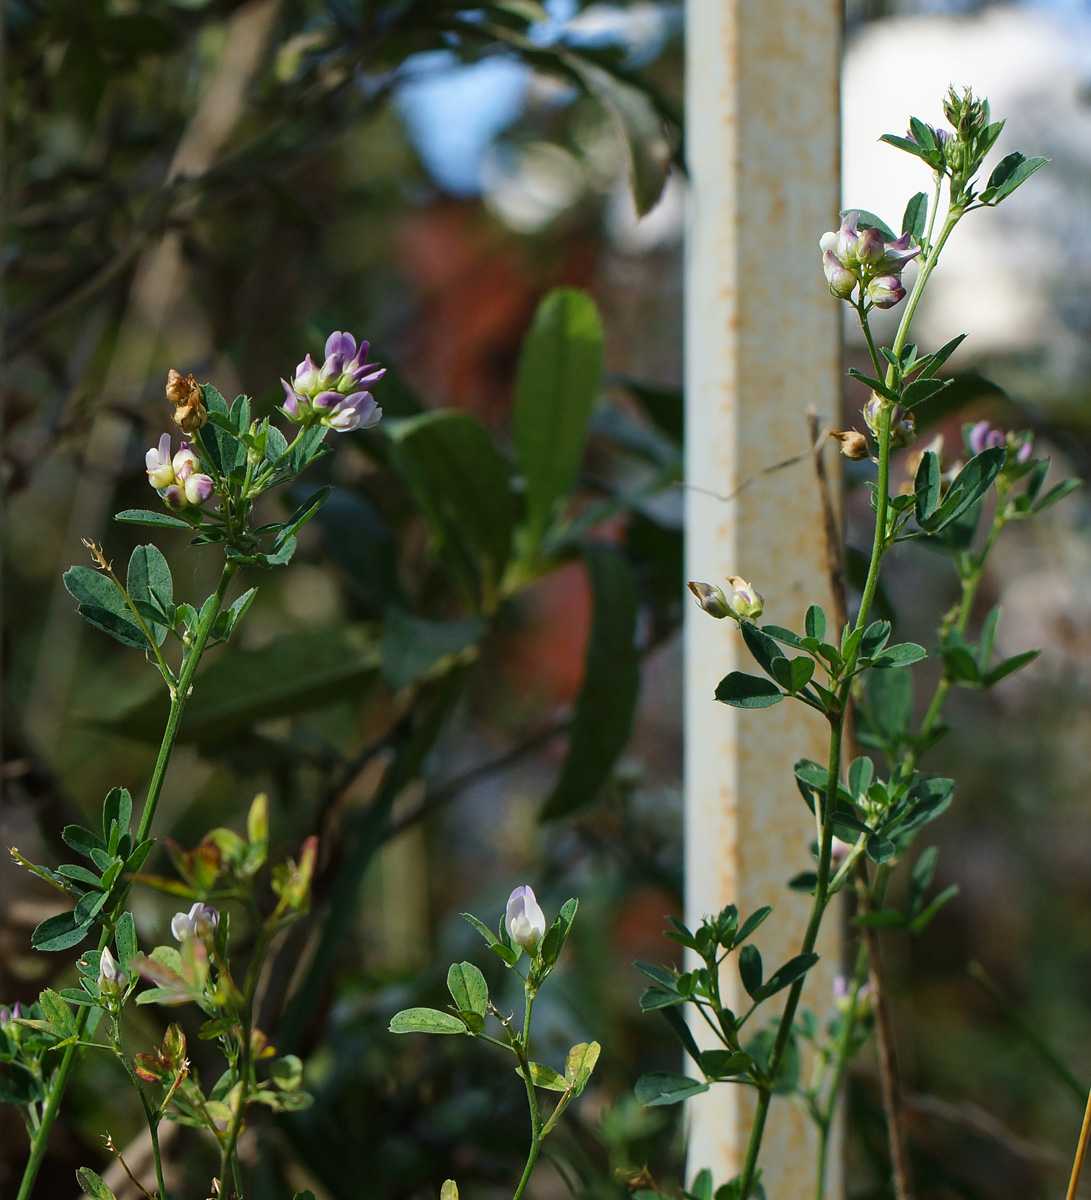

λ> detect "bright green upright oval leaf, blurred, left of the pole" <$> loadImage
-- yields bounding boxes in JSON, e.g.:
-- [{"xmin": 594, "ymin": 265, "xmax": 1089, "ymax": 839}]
[{"xmin": 511, "ymin": 288, "xmax": 603, "ymax": 548}]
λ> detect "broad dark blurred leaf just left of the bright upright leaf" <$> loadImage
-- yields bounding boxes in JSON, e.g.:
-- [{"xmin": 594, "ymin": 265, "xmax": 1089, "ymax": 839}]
[{"xmin": 386, "ymin": 412, "xmax": 514, "ymax": 595}]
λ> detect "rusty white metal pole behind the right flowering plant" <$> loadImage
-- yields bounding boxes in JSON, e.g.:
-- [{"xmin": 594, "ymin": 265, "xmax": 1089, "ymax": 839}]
[{"xmin": 685, "ymin": 0, "xmax": 841, "ymax": 1200}]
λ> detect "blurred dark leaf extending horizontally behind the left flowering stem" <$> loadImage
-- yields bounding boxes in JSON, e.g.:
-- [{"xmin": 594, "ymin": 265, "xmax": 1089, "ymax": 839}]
[{"xmin": 102, "ymin": 626, "xmax": 379, "ymax": 744}]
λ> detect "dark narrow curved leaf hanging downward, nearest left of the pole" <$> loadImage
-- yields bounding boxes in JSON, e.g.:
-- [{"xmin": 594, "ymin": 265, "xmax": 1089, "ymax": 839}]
[{"xmin": 541, "ymin": 545, "xmax": 640, "ymax": 820}]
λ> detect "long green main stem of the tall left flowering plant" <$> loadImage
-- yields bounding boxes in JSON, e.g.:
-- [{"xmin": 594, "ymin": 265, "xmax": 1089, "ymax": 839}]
[{"xmin": 16, "ymin": 563, "xmax": 239, "ymax": 1200}]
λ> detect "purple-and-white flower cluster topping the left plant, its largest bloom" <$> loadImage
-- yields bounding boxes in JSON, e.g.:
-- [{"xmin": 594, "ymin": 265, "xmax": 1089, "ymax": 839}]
[{"xmin": 281, "ymin": 332, "xmax": 386, "ymax": 433}]
